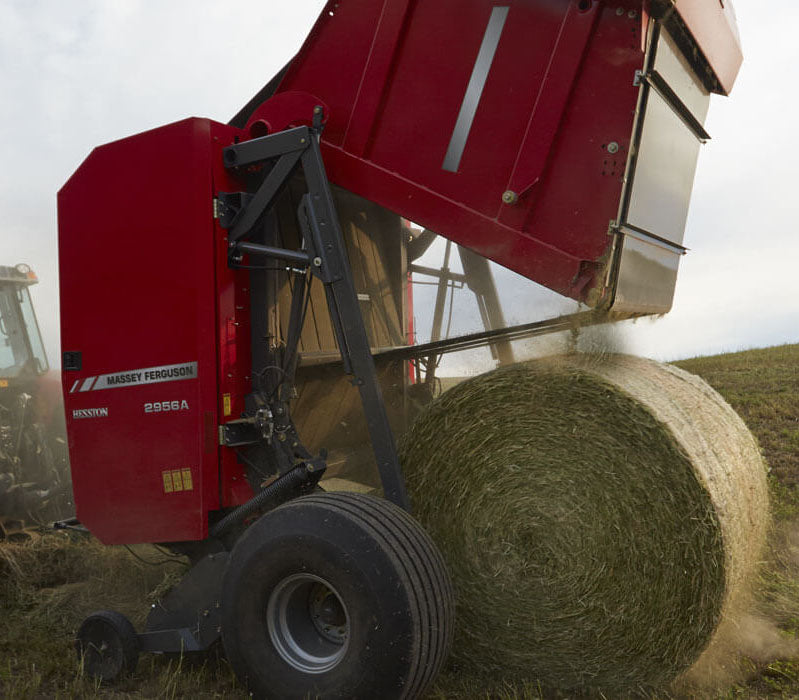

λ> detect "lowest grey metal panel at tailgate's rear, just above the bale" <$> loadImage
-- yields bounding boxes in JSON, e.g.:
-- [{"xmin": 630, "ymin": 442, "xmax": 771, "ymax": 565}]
[{"xmin": 613, "ymin": 232, "xmax": 681, "ymax": 314}]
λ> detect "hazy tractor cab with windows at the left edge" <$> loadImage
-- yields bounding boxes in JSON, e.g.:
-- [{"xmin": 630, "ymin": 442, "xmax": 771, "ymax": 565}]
[{"xmin": 0, "ymin": 263, "xmax": 48, "ymax": 386}]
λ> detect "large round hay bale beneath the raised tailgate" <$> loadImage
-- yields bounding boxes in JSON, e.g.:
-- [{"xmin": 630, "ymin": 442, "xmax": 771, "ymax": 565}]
[{"xmin": 400, "ymin": 355, "xmax": 768, "ymax": 693}]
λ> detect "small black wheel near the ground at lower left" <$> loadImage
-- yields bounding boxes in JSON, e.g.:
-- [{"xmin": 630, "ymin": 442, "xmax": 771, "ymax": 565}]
[{"xmin": 75, "ymin": 610, "xmax": 139, "ymax": 683}]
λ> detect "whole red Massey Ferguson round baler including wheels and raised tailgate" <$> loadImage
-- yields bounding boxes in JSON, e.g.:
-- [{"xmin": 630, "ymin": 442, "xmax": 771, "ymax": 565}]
[{"xmin": 58, "ymin": 0, "xmax": 745, "ymax": 698}]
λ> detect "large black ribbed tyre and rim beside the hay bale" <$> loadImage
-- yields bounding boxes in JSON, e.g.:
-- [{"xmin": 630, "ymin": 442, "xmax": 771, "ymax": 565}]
[{"xmin": 222, "ymin": 493, "xmax": 454, "ymax": 698}]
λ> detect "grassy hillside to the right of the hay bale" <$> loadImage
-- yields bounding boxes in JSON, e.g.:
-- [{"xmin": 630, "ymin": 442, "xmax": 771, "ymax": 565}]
[{"xmin": 676, "ymin": 345, "xmax": 799, "ymax": 698}]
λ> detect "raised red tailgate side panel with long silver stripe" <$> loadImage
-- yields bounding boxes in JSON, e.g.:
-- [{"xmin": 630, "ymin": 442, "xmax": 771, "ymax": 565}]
[{"xmin": 273, "ymin": 0, "xmax": 643, "ymax": 300}]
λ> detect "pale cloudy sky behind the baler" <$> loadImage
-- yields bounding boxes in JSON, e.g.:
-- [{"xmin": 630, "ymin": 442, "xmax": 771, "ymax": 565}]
[{"xmin": 0, "ymin": 0, "xmax": 799, "ymax": 367}]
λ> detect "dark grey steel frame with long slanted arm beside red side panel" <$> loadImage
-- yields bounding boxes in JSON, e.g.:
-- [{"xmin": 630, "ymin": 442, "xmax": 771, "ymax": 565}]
[{"xmin": 218, "ymin": 124, "xmax": 410, "ymax": 510}]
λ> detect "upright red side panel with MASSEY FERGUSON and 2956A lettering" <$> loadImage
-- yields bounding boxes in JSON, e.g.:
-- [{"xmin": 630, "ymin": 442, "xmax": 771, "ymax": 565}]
[{"xmin": 58, "ymin": 119, "xmax": 250, "ymax": 543}]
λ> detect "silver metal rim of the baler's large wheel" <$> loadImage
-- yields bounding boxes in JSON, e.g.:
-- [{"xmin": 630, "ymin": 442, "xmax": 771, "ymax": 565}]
[{"xmin": 266, "ymin": 574, "xmax": 350, "ymax": 673}]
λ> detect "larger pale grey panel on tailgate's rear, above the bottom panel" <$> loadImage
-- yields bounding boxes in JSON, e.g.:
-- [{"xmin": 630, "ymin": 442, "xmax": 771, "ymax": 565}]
[{"xmin": 626, "ymin": 90, "xmax": 709, "ymax": 245}]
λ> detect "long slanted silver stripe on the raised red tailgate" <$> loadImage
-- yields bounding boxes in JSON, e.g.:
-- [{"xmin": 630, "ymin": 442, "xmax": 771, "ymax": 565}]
[{"xmin": 441, "ymin": 7, "xmax": 510, "ymax": 173}]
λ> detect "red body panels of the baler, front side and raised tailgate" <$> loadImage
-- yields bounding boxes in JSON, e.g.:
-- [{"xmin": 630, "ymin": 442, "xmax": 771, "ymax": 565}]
[{"xmin": 59, "ymin": 0, "xmax": 740, "ymax": 543}]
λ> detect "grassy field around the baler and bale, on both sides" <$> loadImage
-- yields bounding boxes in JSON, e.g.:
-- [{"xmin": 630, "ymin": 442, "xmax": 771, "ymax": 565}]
[{"xmin": 0, "ymin": 345, "xmax": 799, "ymax": 700}]
